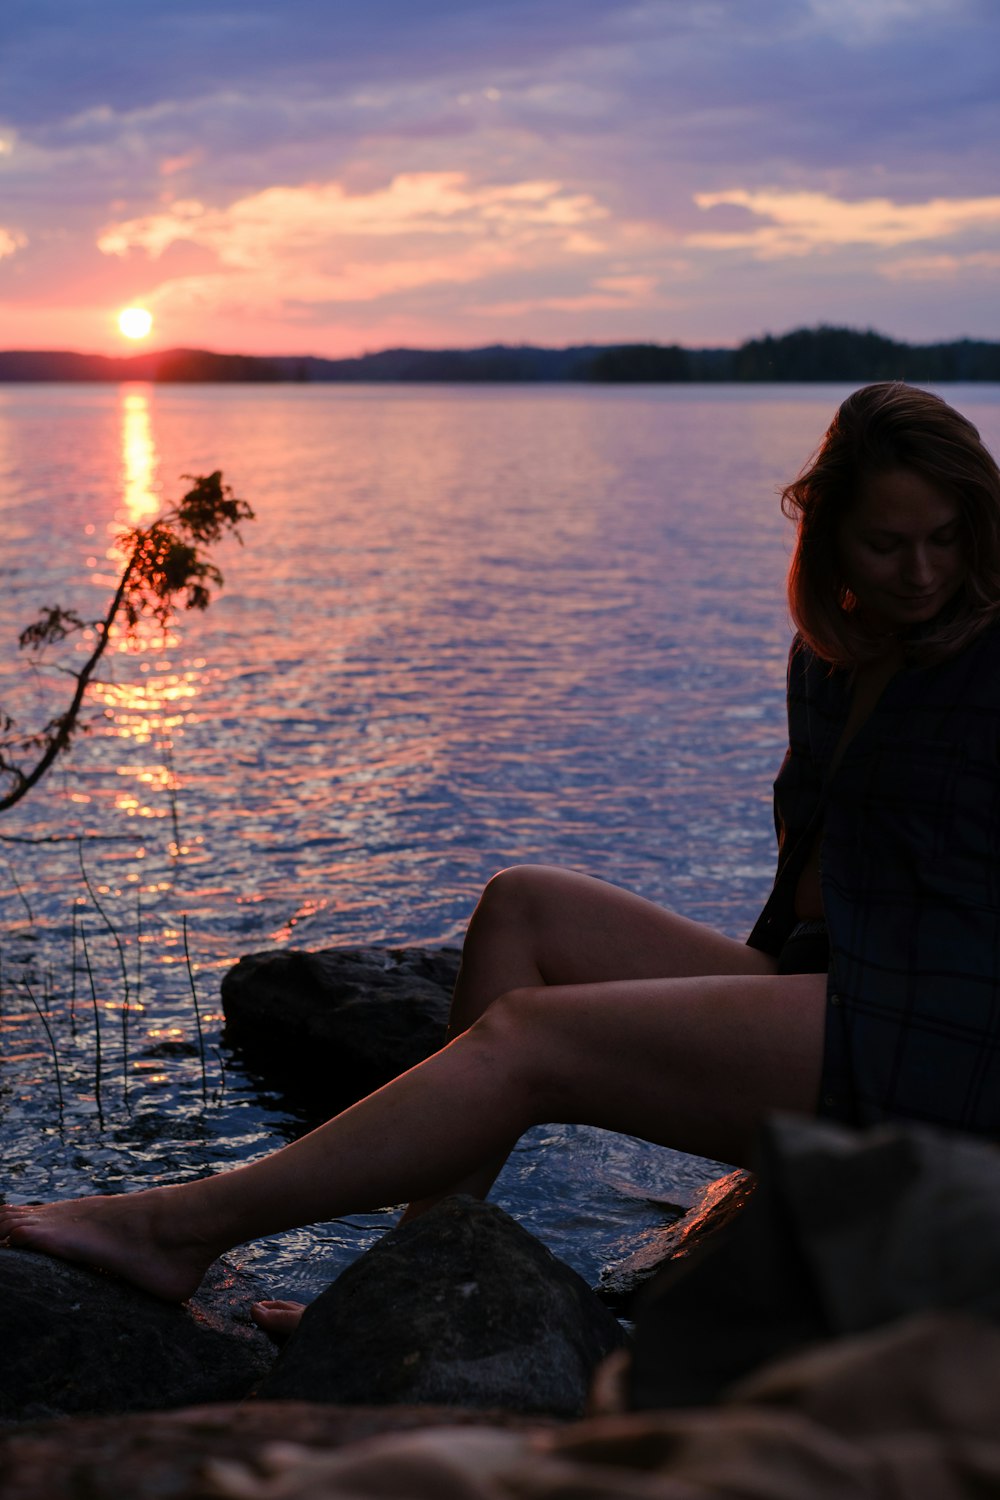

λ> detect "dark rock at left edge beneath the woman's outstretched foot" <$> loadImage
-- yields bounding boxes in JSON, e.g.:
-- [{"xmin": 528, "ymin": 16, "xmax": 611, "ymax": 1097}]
[{"xmin": 0, "ymin": 1248, "xmax": 274, "ymax": 1421}]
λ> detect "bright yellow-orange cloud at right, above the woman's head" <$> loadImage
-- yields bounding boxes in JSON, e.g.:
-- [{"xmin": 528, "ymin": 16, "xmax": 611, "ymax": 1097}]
[{"xmin": 685, "ymin": 188, "xmax": 1000, "ymax": 260}]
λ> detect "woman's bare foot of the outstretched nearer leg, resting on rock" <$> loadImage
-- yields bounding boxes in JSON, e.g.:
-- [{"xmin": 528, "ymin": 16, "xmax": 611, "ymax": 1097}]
[{"xmin": 0, "ymin": 1188, "xmax": 228, "ymax": 1302}]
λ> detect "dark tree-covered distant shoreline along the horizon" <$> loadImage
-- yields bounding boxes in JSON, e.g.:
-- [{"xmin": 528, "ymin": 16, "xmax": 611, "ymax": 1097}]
[{"xmin": 0, "ymin": 326, "xmax": 1000, "ymax": 386}]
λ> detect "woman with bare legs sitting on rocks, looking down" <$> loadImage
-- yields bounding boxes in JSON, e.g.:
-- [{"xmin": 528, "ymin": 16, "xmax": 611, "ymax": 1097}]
[{"xmin": 0, "ymin": 384, "xmax": 1000, "ymax": 1299}]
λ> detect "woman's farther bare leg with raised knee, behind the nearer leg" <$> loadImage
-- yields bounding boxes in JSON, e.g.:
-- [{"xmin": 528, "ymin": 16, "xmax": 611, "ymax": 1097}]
[{"xmin": 403, "ymin": 864, "xmax": 774, "ymax": 1218}]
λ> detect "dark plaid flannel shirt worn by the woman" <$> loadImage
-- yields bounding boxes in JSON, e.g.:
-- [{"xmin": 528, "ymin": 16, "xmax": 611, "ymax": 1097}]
[{"xmin": 748, "ymin": 626, "xmax": 1000, "ymax": 1139}]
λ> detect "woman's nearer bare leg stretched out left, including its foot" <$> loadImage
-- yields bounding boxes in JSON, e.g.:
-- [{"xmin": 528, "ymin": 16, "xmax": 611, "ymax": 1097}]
[{"xmin": 0, "ymin": 975, "xmax": 826, "ymax": 1301}]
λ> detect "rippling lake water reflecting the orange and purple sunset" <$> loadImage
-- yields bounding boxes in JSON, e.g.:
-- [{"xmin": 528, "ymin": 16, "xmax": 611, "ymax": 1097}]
[{"xmin": 0, "ymin": 386, "xmax": 1000, "ymax": 1296}]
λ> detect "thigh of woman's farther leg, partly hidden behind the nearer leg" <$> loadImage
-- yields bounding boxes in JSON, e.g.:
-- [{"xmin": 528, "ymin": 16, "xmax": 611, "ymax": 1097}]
[{"xmin": 466, "ymin": 866, "xmax": 774, "ymax": 986}]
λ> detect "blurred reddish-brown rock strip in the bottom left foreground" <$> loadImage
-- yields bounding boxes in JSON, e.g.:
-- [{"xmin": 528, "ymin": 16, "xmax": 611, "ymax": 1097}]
[{"xmin": 0, "ymin": 1401, "xmax": 553, "ymax": 1500}]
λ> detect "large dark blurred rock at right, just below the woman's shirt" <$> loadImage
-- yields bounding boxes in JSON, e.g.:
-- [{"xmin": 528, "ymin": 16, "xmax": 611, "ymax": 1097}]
[{"xmin": 630, "ymin": 1118, "xmax": 1000, "ymax": 1409}]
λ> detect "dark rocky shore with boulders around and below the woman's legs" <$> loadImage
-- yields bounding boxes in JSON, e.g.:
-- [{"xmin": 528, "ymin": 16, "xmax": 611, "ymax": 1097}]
[{"xmin": 0, "ymin": 950, "xmax": 1000, "ymax": 1500}]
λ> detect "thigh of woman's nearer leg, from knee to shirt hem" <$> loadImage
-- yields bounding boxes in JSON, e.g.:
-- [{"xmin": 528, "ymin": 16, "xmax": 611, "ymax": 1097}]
[{"xmin": 491, "ymin": 974, "xmax": 826, "ymax": 1164}]
